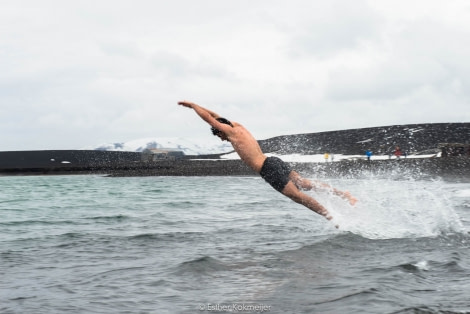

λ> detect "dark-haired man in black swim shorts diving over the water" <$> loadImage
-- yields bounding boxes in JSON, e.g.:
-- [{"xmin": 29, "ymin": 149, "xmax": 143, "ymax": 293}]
[{"xmin": 178, "ymin": 101, "xmax": 357, "ymax": 220}]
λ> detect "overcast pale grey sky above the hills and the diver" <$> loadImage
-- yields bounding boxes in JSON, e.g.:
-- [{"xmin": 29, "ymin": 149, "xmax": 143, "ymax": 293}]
[{"xmin": 0, "ymin": 0, "xmax": 470, "ymax": 151}]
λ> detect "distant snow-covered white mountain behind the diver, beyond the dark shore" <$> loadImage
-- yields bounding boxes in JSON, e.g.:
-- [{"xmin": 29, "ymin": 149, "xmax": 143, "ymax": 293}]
[{"xmin": 83, "ymin": 137, "xmax": 233, "ymax": 155}]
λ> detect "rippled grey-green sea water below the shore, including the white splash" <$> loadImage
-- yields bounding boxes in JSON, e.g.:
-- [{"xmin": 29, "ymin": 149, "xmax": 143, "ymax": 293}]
[{"xmin": 0, "ymin": 175, "xmax": 470, "ymax": 313}]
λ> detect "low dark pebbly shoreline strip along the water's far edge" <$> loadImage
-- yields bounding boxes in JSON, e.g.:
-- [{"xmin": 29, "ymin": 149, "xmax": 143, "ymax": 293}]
[{"xmin": 0, "ymin": 157, "xmax": 470, "ymax": 181}]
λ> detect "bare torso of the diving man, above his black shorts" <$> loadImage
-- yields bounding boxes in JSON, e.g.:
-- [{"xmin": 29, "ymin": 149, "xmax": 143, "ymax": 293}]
[{"xmin": 226, "ymin": 122, "xmax": 266, "ymax": 173}]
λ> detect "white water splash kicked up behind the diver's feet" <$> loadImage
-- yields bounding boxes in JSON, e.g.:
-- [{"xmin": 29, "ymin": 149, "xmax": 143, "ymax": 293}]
[{"xmin": 316, "ymin": 177, "xmax": 464, "ymax": 239}]
